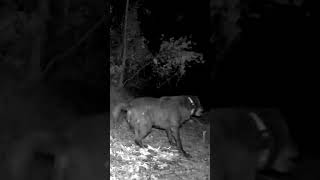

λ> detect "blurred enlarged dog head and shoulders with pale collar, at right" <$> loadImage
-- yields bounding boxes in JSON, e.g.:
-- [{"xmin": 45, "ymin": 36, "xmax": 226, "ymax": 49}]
[{"xmin": 209, "ymin": 108, "xmax": 298, "ymax": 180}]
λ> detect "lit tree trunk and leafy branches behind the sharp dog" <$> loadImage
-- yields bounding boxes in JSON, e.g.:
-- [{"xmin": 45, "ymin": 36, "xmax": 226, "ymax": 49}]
[{"xmin": 110, "ymin": 2, "xmax": 204, "ymax": 89}]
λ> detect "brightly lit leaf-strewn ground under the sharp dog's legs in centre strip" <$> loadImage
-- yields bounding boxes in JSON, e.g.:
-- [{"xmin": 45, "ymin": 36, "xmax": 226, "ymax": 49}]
[{"xmin": 110, "ymin": 118, "xmax": 210, "ymax": 180}]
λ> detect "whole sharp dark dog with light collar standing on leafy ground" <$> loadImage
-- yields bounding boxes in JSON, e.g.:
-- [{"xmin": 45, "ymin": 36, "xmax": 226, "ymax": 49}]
[{"xmin": 113, "ymin": 96, "xmax": 203, "ymax": 157}]
